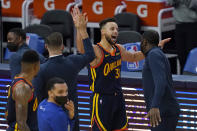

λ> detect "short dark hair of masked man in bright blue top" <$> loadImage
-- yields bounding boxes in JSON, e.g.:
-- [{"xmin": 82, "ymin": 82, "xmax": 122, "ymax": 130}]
[{"xmin": 46, "ymin": 77, "xmax": 66, "ymax": 91}]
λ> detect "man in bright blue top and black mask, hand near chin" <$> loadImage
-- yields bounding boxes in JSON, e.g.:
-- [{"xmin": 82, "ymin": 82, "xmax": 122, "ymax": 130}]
[{"xmin": 38, "ymin": 77, "xmax": 74, "ymax": 131}]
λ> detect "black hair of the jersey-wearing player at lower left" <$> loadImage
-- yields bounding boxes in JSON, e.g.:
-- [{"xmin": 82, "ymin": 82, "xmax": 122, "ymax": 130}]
[{"xmin": 21, "ymin": 50, "xmax": 40, "ymax": 64}]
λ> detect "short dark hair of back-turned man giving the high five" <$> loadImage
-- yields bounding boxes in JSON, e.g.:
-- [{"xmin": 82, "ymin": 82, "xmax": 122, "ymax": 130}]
[{"xmin": 45, "ymin": 32, "xmax": 63, "ymax": 47}]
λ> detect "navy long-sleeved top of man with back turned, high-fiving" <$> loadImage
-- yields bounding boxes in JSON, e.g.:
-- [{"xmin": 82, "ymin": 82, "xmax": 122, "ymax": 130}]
[{"xmin": 33, "ymin": 38, "xmax": 95, "ymax": 119}]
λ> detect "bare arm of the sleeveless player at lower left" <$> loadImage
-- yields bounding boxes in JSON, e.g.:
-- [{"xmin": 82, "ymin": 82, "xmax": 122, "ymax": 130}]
[{"xmin": 13, "ymin": 82, "xmax": 32, "ymax": 131}]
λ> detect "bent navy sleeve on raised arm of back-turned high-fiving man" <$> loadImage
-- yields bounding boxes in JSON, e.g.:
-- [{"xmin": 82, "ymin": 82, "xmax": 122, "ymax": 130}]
[{"xmin": 70, "ymin": 38, "xmax": 95, "ymax": 71}]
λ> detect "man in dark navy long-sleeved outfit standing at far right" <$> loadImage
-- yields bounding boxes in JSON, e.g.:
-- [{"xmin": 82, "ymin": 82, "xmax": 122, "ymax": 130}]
[{"xmin": 141, "ymin": 30, "xmax": 180, "ymax": 131}]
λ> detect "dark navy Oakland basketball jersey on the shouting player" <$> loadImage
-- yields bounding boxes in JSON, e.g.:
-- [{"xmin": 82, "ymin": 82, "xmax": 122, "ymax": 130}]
[{"xmin": 88, "ymin": 43, "xmax": 122, "ymax": 94}]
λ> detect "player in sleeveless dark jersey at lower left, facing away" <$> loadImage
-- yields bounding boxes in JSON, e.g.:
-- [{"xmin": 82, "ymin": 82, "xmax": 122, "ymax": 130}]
[{"xmin": 7, "ymin": 50, "xmax": 40, "ymax": 131}]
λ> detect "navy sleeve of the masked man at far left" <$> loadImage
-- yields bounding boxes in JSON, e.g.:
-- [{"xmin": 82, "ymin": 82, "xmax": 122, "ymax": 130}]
[{"xmin": 9, "ymin": 53, "xmax": 21, "ymax": 80}]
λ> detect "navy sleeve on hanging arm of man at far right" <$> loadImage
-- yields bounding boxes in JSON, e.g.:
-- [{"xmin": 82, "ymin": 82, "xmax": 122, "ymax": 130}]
[{"xmin": 148, "ymin": 52, "xmax": 167, "ymax": 108}]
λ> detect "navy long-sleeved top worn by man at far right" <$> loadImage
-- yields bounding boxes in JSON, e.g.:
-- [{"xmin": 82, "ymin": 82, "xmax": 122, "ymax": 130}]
[{"xmin": 142, "ymin": 47, "xmax": 179, "ymax": 115}]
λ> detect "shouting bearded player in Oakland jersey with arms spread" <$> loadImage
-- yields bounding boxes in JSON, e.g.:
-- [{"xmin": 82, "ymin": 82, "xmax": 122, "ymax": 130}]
[{"xmin": 72, "ymin": 7, "xmax": 169, "ymax": 131}]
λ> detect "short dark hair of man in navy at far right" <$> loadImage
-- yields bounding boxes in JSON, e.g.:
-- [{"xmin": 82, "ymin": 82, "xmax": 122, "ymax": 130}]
[{"xmin": 142, "ymin": 30, "xmax": 159, "ymax": 46}]
